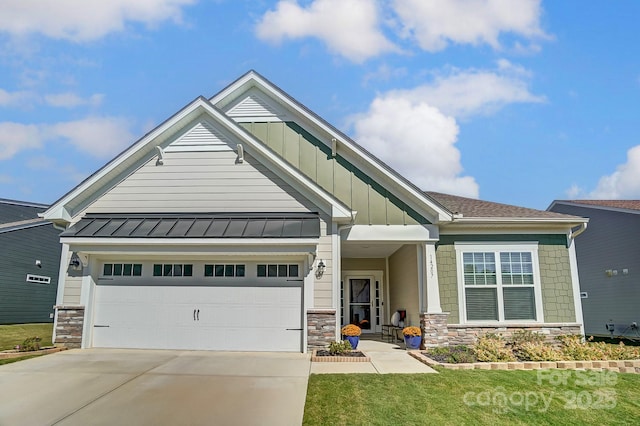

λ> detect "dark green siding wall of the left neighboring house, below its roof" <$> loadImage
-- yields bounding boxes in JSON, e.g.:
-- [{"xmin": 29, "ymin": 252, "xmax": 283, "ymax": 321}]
[{"xmin": 0, "ymin": 224, "xmax": 62, "ymax": 324}]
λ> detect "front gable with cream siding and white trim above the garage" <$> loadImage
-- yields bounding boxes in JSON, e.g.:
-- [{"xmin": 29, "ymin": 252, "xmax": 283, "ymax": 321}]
[{"xmin": 42, "ymin": 97, "xmax": 352, "ymax": 224}]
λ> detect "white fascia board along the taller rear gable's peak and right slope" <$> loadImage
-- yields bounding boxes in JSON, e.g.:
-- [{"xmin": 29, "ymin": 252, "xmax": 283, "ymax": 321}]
[{"xmin": 210, "ymin": 71, "xmax": 452, "ymax": 222}]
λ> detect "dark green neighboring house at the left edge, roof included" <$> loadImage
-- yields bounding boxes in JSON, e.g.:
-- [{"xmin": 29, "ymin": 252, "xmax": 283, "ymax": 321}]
[{"xmin": 0, "ymin": 199, "xmax": 62, "ymax": 324}]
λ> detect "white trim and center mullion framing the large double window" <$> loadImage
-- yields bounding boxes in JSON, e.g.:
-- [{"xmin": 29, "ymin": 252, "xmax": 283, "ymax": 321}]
[{"xmin": 454, "ymin": 242, "xmax": 544, "ymax": 325}]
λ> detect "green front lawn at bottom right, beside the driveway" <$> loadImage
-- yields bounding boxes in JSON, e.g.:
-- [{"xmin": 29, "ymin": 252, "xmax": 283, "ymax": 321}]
[{"xmin": 303, "ymin": 369, "xmax": 640, "ymax": 426}]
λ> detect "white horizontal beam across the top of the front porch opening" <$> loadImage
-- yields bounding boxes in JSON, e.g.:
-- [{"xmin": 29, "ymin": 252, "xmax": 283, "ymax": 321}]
[{"xmin": 342, "ymin": 225, "xmax": 440, "ymax": 242}]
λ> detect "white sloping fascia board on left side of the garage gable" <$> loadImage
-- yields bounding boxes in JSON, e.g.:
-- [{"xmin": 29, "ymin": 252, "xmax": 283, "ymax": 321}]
[{"xmin": 42, "ymin": 97, "xmax": 207, "ymax": 222}]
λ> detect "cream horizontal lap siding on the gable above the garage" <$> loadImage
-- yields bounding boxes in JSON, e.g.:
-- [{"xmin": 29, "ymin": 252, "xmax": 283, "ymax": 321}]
[{"xmin": 85, "ymin": 151, "xmax": 314, "ymax": 213}]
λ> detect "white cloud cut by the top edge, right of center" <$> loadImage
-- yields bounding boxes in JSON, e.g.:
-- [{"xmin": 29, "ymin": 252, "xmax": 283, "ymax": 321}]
[{"xmin": 392, "ymin": 0, "xmax": 546, "ymax": 52}]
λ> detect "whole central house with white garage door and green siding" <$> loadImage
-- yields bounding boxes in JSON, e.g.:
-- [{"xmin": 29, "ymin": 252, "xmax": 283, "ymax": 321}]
[{"xmin": 42, "ymin": 71, "xmax": 586, "ymax": 352}]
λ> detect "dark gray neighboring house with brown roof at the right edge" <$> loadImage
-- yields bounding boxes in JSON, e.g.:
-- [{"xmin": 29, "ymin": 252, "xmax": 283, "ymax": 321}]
[{"xmin": 548, "ymin": 200, "xmax": 640, "ymax": 339}]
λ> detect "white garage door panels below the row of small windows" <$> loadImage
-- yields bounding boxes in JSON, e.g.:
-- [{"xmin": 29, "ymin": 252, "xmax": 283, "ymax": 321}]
[{"xmin": 92, "ymin": 283, "xmax": 302, "ymax": 352}]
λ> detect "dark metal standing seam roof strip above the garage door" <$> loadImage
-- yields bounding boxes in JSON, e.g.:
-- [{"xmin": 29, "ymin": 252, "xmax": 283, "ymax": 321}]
[{"xmin": 60, "ymin": 213, "xmax": 320, "ymax": 238}]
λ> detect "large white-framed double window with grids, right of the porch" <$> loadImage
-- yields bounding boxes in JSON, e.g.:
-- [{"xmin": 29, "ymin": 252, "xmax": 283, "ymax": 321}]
[{"xmin": 456, "ymin": 244, "xmax": 542, "ymax": 321}]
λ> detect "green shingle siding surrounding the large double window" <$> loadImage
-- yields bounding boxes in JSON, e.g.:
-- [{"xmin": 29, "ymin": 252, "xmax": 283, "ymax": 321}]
[{"xmin": 436, "ymin": 234, "xmax": 576, "ymax": 324}]
